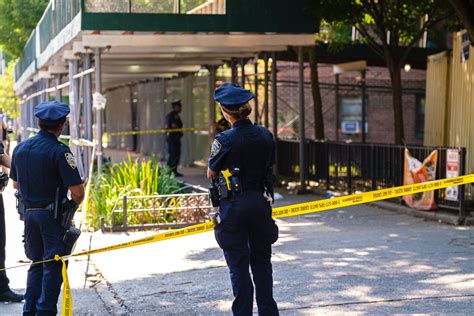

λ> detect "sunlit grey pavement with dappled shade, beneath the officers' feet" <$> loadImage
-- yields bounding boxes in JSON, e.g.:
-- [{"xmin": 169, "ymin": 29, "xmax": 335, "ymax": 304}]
[{"xmin": 0, "ymin": 183, "xmax": 474, "ymax": 315}]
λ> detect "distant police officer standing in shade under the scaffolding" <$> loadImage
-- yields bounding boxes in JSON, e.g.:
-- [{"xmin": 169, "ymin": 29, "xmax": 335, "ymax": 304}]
[{"xmin": 166, "ymin": 100, "xmax": 183, "ymax": 177}]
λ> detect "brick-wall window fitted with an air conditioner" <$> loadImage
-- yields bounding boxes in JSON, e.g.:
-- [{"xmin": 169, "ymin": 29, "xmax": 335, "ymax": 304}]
[{"xmin": 341, "ymin": 98, "xmax": 369, "ymax": 134}]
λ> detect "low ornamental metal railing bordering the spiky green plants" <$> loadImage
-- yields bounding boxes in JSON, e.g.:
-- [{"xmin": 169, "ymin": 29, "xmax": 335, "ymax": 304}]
[{"xmin": 101, "ymin": 192, "xmax": 212, "ymax": 231}]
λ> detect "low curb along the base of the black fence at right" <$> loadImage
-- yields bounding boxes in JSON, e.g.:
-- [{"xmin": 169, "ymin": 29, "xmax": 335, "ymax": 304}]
[{"xmin": 369, "ymin": 201, "xmax": 466, "ymax": 226}]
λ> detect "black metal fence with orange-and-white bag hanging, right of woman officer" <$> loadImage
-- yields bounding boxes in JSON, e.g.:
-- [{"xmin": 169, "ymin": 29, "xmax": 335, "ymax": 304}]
[{"xmin": 278, "ymin": 140, "xmax": 466, "ymax": 216}]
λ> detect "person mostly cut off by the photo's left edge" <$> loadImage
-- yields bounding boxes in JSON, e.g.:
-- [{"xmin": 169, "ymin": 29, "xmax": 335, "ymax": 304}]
[{"xmin": 0, "ymin": 144, "xmax": 23, "ymax": 302}]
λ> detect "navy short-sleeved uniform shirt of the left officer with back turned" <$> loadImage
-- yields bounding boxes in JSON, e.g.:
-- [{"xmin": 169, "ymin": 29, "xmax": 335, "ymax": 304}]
[{"xmin": 10, "ymin": 131, "xmax": 82, "ymax": 208}]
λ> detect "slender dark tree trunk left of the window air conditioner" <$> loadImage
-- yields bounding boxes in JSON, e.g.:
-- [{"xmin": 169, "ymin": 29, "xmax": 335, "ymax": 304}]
[{"xmin": 309, "ymin": 47, "xmax": 325, "ymax": 140}]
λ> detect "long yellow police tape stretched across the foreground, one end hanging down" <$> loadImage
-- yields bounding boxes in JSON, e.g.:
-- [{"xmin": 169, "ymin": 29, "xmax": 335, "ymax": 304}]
[{"xmin": 0, "ymin": 174, "xmax": 474, "ymax": 316}]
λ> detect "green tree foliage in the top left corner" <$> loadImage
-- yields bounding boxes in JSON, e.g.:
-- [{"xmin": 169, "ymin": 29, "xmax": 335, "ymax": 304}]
[{"xmin": 0, "ymin": 0, "xmax": 50, "ymax": 57}]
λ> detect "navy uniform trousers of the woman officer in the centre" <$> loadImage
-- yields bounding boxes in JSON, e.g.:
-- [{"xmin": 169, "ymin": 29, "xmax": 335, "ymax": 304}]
[{"xmin": 214, "ymin": 192, "xmax": 278, "ymax": 316}]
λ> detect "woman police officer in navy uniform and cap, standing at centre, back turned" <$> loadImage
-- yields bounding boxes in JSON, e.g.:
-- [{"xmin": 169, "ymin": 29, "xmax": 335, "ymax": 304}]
[{"xmin": 208, "ymin": 83, "xmax": 278, "ymax": 315}]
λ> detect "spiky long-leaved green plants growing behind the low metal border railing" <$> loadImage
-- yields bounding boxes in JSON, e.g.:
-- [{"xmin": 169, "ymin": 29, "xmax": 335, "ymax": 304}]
[{"xmin": 88, "ymin": 157, "xmax": 180, "ymax": 229}]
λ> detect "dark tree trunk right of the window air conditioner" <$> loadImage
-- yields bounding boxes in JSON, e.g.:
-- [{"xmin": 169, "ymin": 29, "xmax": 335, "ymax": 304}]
[{"xmin": 387, "ymin": 61, "xmax": 405, "ymax": 145}]
